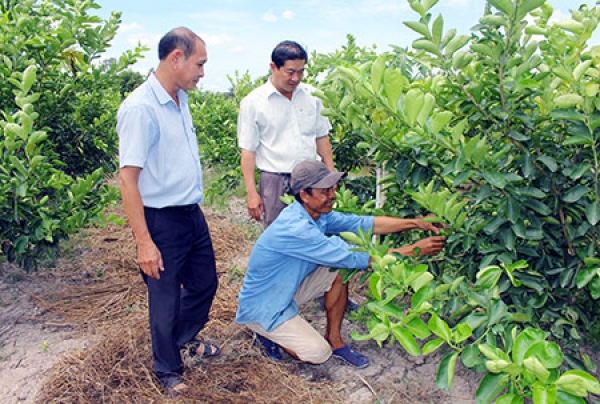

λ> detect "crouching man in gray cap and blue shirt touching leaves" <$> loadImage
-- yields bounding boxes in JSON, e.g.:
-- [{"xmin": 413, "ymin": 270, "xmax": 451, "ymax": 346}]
[{"xmin": 236, "ymin": 160, "xmax": 446, "ymax": 368}]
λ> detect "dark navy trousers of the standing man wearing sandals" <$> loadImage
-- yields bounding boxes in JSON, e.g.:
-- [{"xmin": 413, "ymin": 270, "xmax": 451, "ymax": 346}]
[{"xmin": 142, "ymin": 204, "xmax": 218, "ymax": 379}]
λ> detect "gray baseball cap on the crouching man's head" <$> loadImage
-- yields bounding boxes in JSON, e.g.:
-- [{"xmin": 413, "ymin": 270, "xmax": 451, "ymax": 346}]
[{"xmin": 290, "ymin": 160, "xmax": 348, "ymax": 195}]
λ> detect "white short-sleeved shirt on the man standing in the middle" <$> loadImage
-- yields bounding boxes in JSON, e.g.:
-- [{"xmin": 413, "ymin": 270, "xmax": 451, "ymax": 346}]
[{"xmin": 238, "ymin": 80, "xmax": 331, "ymax": 173}]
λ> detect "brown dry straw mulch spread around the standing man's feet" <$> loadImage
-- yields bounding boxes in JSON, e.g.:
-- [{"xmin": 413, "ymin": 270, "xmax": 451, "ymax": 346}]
[{"xmin": 30, "ymin": 208, "xmax": 342, "ymax": 403}]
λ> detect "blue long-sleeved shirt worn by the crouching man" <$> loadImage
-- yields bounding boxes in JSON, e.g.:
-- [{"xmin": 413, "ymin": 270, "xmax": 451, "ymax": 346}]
[{"xmin": 236, "ymin": 202, "xmax": 374, "ymax": 332}]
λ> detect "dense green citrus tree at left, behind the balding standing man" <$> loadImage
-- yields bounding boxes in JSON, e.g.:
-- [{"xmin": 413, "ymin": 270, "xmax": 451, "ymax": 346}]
[{"xmin": 0, "ymin": 0, "xmax": 143, "ymax": 269}]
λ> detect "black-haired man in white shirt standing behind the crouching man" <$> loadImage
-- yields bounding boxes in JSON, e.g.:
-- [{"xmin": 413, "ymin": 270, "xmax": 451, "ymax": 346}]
[{"xmin": 238, "ymin": 41, "xmax": 335, "ymax": 228}]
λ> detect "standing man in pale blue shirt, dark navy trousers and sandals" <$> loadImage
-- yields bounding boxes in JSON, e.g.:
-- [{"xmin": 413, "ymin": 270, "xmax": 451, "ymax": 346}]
[{"xmin": 117, "ymin": 27, "xmax": 220, "ymax": 395}]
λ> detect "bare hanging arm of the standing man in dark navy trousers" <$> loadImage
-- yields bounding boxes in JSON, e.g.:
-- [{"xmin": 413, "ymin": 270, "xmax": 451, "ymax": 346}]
[{"xmin": 119, "ymin": 166, "xmax": 165, "ymax": 279}]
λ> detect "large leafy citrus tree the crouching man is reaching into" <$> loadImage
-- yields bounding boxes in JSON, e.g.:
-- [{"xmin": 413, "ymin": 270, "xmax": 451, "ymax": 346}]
[{"xmin": 318, "ymin": 0, "xmax": 600, "ymax": 402}]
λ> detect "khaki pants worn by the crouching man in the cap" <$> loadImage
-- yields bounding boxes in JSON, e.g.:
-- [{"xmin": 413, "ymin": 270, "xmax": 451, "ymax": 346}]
[{"xmin": 246, "ymin": 267, "xmax": 338, "ymax": 364}]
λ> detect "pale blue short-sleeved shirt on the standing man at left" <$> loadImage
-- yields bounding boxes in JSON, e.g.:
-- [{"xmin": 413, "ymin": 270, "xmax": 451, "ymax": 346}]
[{"xmin": 117, "ymin": 74, "xmax": 203, "ymax": 208}]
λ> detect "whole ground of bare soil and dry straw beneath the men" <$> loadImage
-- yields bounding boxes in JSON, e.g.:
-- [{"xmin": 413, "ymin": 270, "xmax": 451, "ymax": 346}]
[{"xmin": 0, "ymin": 197, "xmax": 480, "ymax": 404}]
